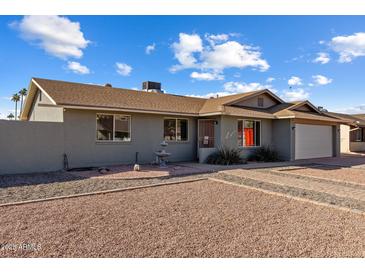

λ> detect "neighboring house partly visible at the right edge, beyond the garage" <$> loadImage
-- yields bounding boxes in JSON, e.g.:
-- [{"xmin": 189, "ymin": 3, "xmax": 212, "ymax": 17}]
[{"xmin": 328, "ymin": 112, "xmax": 365, "ymax": 153}]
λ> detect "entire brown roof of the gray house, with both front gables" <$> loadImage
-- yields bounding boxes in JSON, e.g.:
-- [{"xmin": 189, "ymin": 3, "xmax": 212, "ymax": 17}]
[{"xmin": 21, "ymin": 78, "xmax": 342, "ymax": 122}]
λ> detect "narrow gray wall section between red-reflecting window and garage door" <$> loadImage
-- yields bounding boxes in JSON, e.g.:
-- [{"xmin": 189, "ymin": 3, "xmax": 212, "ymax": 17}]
[{"xmin": 272, "ymin": 119, "xmax": 294, "ymax": 161}]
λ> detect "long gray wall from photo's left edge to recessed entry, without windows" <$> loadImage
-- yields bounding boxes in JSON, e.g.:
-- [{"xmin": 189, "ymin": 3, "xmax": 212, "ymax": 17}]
[{"xmin": 0, "ymin": 109, "xmax": 197, "ymax": 174}]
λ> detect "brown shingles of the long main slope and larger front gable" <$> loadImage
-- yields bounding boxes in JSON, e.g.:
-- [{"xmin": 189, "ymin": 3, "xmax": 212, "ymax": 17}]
[{"xmin": 33, "ymin": 78, "xmax": 274, "ymax": 118}]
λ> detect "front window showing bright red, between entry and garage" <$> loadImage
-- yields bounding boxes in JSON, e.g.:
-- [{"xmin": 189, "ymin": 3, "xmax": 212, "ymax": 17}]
[{"xmin": 237, "ymin": 120, "xmax": 261, "ymax": 147}]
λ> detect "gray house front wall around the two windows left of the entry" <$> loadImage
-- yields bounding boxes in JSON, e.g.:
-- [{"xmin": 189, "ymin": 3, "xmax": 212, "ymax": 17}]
[{"xmin": 64, "ymin": 109, "xmax": 197, "ymax": 167}]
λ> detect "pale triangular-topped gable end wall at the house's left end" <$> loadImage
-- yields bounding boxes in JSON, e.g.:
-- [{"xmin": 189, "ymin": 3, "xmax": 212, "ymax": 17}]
[{"xmin": 29, "ymin": 90, "xmax": 63, "ymax": 122}]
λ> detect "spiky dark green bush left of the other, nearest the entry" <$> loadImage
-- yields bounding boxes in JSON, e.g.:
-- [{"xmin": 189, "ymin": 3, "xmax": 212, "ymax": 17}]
[{"xmin": 206, "ymin": 146, "xmax": 245, "ymax": 165}]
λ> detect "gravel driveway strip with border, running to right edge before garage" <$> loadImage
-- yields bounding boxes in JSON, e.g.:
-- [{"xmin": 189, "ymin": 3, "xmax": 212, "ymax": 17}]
[{"xmin": 215, "ymin": 167, "xmax": 365, "ymax": 212}]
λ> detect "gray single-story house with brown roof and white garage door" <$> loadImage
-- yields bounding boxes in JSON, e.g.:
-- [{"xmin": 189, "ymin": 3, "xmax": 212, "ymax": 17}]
[{"xmin": 14, "ymin": 78, "xmax": 343, "ymax": 167}]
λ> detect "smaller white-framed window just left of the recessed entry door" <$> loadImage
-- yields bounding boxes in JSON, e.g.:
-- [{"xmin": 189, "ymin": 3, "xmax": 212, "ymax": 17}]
[{"xmin": 164, "ymin": 119, "xmax": 188, "ymax": 141}]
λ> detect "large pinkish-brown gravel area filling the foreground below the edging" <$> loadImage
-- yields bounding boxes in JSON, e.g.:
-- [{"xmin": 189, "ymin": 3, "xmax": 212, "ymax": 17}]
[{"xmin": 0, "ymin": 181, "xmax": 365, "ymax": 257}]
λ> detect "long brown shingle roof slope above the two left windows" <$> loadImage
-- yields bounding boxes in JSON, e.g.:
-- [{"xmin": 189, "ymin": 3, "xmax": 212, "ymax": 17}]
[{"xmin": 34, "ymin": 78, "xmax": 206, "ymax": 115}]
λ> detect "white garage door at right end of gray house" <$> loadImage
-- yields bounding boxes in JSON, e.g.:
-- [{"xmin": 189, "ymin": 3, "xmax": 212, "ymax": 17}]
[{"xmin": 295, "ymin": 124, "xmax": 333, "ymax": 159}]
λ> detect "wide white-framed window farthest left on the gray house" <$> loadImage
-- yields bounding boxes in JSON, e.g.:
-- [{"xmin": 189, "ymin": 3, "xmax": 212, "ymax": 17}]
[{"xmin": 96, "ymin": 114, "xmax": 131, "ymax": 142}]
